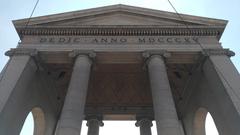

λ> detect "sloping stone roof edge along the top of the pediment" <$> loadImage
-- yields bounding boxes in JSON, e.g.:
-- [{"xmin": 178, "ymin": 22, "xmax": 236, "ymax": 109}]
[{"xmin": 13, "ymin": 4, "xmax": 227, "ymax": 27}]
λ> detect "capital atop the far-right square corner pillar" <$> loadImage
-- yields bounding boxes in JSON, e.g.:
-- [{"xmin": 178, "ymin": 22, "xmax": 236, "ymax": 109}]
[{"xmin": 203, "ymin": 49, "xmax": 235, "ymax": 57}]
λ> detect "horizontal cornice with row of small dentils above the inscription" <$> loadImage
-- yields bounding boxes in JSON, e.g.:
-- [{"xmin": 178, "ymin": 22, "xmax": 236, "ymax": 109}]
[{"xmin": 17, "ymin": 25, "xmax": 223, "ymax": 38}]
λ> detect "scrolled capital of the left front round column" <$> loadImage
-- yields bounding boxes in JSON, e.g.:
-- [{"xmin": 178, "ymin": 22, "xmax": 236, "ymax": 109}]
[{"xmin": 69, "ymin": 50, "xmax": 96, "ymax": 59}]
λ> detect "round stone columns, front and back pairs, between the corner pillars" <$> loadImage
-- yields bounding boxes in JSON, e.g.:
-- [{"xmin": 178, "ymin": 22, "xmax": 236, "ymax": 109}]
[{"xmin": 56, "ymin": 51, "xmax": 182, "ymax": 135}]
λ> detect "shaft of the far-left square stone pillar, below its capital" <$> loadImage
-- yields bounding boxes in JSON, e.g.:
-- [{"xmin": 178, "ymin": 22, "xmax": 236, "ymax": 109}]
[{"xmin": 0, "ymin": 55, "xmax": 37, "ymax": 135}]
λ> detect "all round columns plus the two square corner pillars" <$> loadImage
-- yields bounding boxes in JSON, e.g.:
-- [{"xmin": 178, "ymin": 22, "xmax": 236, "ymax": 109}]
[{"xmin": 0, "ymin": 49, "xmax": 240, "ymax": 135}]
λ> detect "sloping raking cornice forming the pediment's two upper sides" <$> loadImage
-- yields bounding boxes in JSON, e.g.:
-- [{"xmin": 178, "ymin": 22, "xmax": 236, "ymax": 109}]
[{"xmin": 13, "ymin": 4, "xmax": 227, "ymax": 27}]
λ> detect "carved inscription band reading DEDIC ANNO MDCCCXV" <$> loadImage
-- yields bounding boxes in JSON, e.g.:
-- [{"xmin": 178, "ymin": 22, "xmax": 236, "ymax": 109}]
[{"xmin": 38, "ymin": 36, "xmax": 199, "ymax": 45}]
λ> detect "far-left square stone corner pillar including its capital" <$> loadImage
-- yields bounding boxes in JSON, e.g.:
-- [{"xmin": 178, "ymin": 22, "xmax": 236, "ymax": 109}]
[{"xmin": 0, "ymin": 48, "xmax": 37, "ymax": 135}]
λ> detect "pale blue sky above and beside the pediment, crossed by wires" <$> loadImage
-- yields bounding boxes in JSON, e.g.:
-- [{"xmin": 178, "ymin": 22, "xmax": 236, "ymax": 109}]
[{"xmin": 0, "ymin": 0, "xmax": 240, "ymax": 135}]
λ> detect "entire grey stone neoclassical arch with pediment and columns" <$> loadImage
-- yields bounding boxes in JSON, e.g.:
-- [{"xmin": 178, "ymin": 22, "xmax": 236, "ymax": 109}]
[{"xmin": 0, "ymin": 5, "xmax": 240, "ymax": 135}]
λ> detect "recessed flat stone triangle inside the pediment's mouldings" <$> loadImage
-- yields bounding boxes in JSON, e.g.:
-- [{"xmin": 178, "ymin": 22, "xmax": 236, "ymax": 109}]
[{"xmin": 38, "ymin": 12, "xmax": 188, "ymax": 26}]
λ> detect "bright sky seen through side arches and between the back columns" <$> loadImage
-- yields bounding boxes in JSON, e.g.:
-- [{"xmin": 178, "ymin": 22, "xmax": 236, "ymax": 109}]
[{"xmin": 20, "ymin": 113, "xmax": 218, "ymax": 135}]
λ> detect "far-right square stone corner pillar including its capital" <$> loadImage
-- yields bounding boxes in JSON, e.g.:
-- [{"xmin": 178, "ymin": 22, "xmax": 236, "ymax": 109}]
[{"xmin": 203, "ymin": 49, "xmax": 240, "ymax": 114}]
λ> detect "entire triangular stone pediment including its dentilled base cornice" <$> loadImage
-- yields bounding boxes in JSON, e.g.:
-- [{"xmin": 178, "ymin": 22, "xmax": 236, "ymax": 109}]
[{"xmin": 13, "ymin": 5, "xmax": 227, "ymax": 39}]
